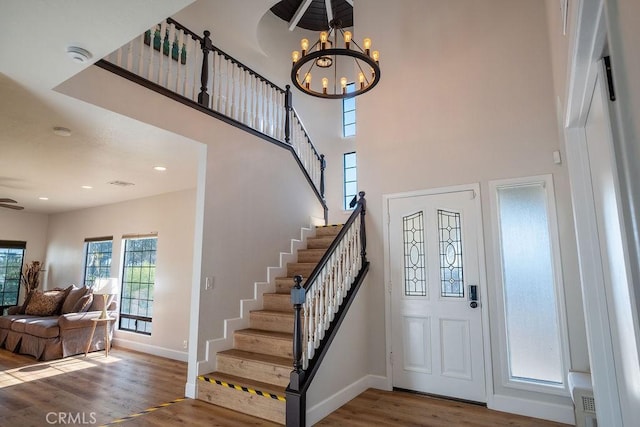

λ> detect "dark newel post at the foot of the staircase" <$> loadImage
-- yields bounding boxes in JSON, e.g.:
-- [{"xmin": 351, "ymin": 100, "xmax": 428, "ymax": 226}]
[{"xmin": 285, "ymin": 276, "xmax": 307, "ymax": 426}]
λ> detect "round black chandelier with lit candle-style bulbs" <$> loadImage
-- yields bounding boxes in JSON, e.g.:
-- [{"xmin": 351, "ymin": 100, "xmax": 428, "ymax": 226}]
[{"xmin": 291, "ymin": 20, "xmax": 380, "ymax": 99}]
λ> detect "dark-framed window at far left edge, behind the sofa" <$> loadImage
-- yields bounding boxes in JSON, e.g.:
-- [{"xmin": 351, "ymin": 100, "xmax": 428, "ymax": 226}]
[{"xmin": 0, "ymin": 240, "xmax": 27, "ymax": 314}]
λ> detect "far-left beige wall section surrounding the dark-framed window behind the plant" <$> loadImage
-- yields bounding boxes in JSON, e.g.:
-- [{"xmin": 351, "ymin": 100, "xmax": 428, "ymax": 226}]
[{"xmin": 0, "ymin": 208, "xmax": 49, "ymax": 302}]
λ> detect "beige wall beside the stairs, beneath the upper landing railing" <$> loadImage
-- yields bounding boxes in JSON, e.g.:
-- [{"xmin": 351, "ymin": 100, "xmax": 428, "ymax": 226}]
[{"xmin": 59, "ymin": 67, "xmax": 323, "ymax": 360}]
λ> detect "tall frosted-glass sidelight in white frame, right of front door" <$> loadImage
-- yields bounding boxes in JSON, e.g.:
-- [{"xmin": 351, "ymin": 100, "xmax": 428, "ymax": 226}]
[{"xmin": 490, "ymin": 175, "xmax": 568, "ymax": 391}]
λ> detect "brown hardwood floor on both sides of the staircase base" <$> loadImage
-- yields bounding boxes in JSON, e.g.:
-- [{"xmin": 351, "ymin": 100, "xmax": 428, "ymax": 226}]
[{"xmin": 0, "ymin": 348, "xmax": 564, "ymax": 427}]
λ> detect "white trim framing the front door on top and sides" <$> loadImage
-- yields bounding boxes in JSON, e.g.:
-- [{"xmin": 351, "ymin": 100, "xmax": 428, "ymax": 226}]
[{"xmin": 382, "ymin": 183, "xmax": 493, "ymax": 401}]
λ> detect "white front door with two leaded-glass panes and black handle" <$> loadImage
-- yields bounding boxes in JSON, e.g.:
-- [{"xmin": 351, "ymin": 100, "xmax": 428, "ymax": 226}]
[{"xmin": 389, "ymin": 190, "xmax": 486, "ymax": 402}]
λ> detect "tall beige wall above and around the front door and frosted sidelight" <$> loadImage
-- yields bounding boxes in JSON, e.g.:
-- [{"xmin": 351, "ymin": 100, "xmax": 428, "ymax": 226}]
[{"xmin": 355, "ymin": 0, "xmax": 588, "ymax": 414}]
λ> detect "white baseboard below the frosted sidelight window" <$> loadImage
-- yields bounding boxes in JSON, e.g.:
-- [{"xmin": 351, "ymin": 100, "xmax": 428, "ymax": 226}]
[{"xmin": 487, "ymin": 394, "xmax": 576, "ymax": 425}]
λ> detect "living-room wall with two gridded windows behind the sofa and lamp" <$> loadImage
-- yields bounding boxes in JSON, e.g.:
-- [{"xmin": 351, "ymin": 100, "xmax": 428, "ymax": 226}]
[{"xmin": 46, "ymin": 190, "xmax": 195, "ymax": 360}]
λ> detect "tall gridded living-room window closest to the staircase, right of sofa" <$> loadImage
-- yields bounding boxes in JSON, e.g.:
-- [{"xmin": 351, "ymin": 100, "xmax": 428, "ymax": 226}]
[{"xmin": 120, "ymin": 236, "xmax": 158, "ymax": 335}]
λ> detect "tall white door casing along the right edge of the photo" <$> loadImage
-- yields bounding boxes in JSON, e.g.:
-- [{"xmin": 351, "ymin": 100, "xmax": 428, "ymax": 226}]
[{"xmin": 564, "ymin": 0, "xmax": 623, "ymax": 425}]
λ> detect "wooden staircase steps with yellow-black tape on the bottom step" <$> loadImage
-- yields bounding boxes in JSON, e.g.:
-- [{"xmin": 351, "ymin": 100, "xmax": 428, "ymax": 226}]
[{"xmin": 198, "ymin": 225, "xmax": 342, "ymax": 424}]
